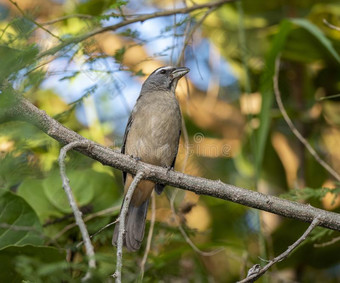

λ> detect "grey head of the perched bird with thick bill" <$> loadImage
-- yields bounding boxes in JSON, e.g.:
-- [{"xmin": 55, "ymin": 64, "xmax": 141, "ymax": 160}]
[{"xmin": 142, "ymin": 66, "xmax": 190, "ymax": 92}]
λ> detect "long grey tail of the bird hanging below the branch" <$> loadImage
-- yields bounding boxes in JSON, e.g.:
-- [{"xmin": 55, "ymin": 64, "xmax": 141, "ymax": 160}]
[{"xmin": 112, "ymin": 198, "xmax": 149, "ymax": 252}]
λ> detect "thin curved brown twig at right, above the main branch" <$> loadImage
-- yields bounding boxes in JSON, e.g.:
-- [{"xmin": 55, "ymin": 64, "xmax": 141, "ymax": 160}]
[{"xmin": 273, "ymin": 56, "xmax": 340, "ymax": 182}]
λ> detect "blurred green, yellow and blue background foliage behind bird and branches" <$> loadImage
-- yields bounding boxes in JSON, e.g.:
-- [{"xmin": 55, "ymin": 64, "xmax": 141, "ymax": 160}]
[{"xmin": 0, "ymin": 0, "xmax": 340, "ymax": 282}]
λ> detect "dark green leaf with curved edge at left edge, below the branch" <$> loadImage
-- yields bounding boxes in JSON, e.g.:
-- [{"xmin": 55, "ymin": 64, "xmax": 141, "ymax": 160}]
[{"xmin": 0, "ymin": 191, "xmax": 43, "ymax": 249}]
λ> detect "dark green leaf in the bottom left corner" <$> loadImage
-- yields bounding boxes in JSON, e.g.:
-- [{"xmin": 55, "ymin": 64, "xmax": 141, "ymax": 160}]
[{"xmin": 0, "ymin": 245, "xmax": 68, "ymax": 283}]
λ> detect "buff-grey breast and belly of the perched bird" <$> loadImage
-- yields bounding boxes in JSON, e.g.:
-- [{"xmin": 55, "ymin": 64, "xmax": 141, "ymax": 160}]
[{"xmin": 125, "ymin": 94, "xmax": 181, "ymax": 166}]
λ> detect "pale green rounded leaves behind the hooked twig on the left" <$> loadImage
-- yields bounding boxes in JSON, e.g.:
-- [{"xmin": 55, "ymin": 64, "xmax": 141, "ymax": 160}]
[{"xmin": 18, "ymin": 169, "xmax": 120, "ymax": 227}]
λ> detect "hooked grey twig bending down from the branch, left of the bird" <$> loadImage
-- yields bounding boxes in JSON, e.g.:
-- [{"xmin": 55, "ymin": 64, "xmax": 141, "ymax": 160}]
[{"xmin": 59, "ymin": 141, "xmax": 96, "ymax": 280}]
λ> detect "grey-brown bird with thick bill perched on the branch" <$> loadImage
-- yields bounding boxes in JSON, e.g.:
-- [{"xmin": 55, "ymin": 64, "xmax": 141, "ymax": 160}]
[{"xmin": 112, "ymin": 66, "xmax": 190, "ymax": 252}]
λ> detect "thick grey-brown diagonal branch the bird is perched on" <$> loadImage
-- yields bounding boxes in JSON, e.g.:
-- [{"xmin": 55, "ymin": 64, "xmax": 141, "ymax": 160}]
[{"xmin": 0, "ymin": 93, "xmax": 340, "ymax": 231}]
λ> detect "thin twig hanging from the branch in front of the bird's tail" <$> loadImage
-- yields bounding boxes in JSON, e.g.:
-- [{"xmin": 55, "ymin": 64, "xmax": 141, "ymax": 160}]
[{"xmin": 113, "ymin": 171, "xmax": 145, "ymax": 283}]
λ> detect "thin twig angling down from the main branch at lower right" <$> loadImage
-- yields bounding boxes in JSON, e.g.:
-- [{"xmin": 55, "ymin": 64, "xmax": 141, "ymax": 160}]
[{"xmin": 238, "ymin": 217, "xmax": 319, "ymax": 283}]
